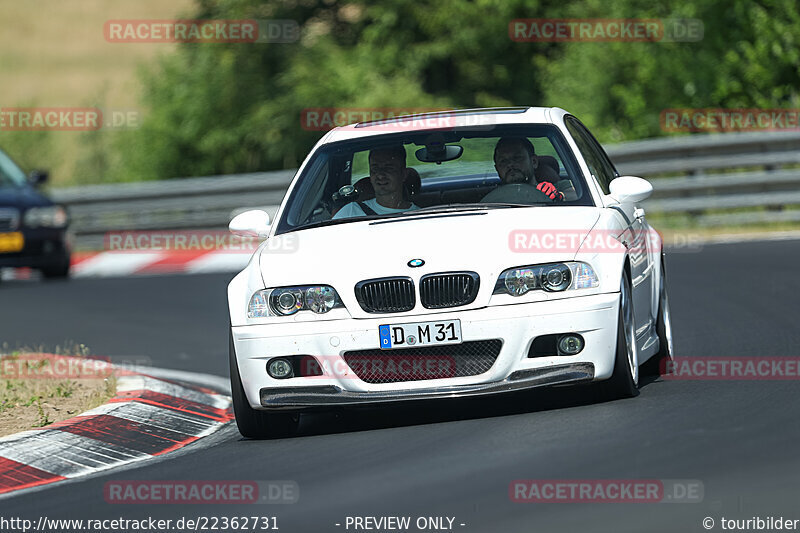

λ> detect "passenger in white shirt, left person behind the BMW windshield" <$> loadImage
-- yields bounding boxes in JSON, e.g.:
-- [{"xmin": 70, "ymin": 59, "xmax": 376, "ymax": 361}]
[{"xmin": 333, "ymin": 145, "xmax": 419, "ymax": 219}]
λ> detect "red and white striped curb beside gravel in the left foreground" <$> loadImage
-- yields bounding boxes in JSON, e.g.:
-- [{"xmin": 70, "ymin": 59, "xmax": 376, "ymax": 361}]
[{"xmin": 0, "ymin": 364, "xmax": 233, "ymax": 494}]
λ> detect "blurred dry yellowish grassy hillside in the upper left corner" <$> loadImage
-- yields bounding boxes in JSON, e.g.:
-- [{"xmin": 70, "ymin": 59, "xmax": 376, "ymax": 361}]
[{"xmin": 0, "ymin": 0, "xmax": 194, "ymax": 185}]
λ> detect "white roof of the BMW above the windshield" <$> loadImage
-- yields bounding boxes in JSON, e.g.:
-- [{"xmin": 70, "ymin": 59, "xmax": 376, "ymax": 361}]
[{"xmin": 321, "ymin": 106, "xmax": 567, "ymax": 144}]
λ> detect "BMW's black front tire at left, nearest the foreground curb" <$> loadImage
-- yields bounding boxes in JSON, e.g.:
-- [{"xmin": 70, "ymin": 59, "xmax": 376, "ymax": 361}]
[{"xmin": 229, "ymin": 330, "xmax": 300, "ymax": 439}]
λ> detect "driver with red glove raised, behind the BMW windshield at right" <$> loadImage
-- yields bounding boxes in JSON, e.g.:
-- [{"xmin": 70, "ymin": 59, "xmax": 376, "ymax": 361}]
[{"xmin": 494, "ymin": 137, "xmax": 564, "ymax": 202}]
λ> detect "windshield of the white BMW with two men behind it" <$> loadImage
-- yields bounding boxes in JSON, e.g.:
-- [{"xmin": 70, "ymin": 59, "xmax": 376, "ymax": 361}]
[{"xmin": 276, "ymin": 125, "xmax": 594, "ymax": 233}]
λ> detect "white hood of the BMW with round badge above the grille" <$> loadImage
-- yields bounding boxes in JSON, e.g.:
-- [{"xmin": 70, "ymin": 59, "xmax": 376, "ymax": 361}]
[{"xmin": 260, "ymin": 206, "xmax": 600, "ymax": 316}]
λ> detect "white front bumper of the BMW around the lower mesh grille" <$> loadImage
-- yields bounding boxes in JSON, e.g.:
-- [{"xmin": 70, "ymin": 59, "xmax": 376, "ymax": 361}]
[{"xmin": 232, "ymin": 293, "xmax": 619, "ymax": 409}]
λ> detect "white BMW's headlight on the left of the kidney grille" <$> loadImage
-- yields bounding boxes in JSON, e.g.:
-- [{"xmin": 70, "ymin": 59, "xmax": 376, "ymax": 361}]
[{"xmin": 247, "ymin": 285, "xmax": 344, "ymax": 318}]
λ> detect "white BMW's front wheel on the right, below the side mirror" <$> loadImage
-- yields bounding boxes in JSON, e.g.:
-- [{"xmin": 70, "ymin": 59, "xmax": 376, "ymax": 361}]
[{"xmin": 602, "ymin": 272, "xmax": 639, "ymax": 399}]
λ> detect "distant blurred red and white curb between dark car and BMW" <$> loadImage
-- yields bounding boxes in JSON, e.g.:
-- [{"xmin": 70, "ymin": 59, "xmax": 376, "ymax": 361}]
[{"xmin": 0, "ymin": 250, "xmax": 252, "ymax": 280}]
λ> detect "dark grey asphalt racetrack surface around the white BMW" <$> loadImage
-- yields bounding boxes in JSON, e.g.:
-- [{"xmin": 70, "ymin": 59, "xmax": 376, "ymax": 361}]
[{"xmin": 0, "ymin": 241, "xmax": 800, "ymax": 533}]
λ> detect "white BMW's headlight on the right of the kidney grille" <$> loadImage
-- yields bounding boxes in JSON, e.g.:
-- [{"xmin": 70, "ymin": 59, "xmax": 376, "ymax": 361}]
[{"xmin": 494, "ymin": 261, "xmax": 600, "ymax": 296}]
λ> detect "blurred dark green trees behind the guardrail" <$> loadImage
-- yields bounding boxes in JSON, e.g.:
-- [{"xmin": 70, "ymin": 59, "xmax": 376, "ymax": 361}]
[{"xmin": 0, "ymin": 0, "xmax": 800, "ymax": 182}]
